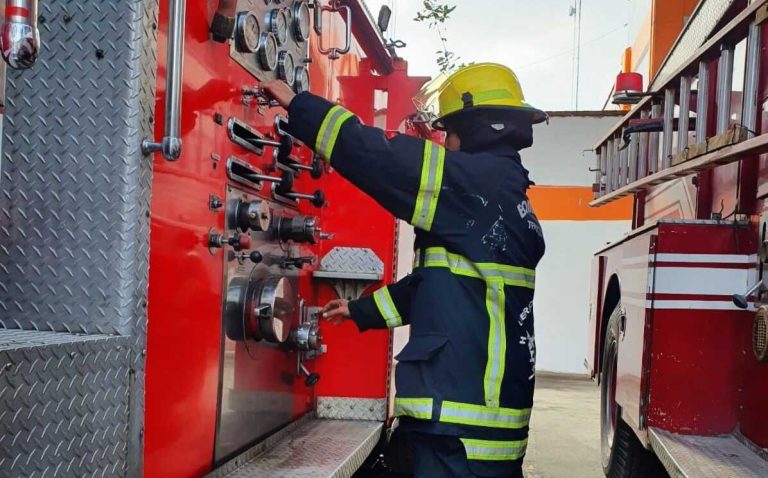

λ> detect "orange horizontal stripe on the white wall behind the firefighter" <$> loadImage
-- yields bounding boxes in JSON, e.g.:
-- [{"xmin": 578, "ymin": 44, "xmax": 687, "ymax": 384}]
[{"xmin": 528, "ymin": 186, "xmax": 632, "ymax": 221}]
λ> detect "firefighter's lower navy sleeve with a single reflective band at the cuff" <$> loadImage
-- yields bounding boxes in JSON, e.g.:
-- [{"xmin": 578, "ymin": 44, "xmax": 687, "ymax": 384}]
[{"xmin": 349, "ymin": 275, "xmax": 419, "ymax": 332}]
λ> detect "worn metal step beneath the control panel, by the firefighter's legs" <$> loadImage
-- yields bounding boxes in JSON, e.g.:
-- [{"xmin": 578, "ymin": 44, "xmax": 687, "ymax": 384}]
[{"xmin": 208, "ymin": 418, "xmax": 384, "ymax": 478}]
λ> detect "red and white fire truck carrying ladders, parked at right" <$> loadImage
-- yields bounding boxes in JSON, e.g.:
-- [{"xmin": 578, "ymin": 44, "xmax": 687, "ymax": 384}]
[{"xmin": 586, "ymin": 0, "xmax": 768, "ymax": 477}]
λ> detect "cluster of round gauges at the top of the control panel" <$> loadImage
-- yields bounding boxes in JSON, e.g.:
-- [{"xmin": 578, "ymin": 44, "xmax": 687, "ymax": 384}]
[{"xmin": 230, "ymin": 0, "xmax": 312, "ymax": 93}]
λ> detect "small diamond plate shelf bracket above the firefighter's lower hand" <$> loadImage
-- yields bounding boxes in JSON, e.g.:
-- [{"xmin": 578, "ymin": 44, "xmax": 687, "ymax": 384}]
[{"xmin": 314, "ymin": 247, "xmax": 384, "ymax": 280}]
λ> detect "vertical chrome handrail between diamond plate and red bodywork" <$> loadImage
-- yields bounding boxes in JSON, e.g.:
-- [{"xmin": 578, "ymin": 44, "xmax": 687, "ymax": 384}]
[{"xmin": 141, "ymin": 0, "xmax": 187, "ymax": 161}]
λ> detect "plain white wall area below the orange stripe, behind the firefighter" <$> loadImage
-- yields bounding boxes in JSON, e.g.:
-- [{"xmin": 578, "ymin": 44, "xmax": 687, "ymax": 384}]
[{"xmin": 533, "ymin": 221, "xmax": 631, "ymax": 374}]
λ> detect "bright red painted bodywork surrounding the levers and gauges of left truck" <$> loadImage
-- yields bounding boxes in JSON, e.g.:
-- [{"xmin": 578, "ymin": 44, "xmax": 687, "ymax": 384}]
[{"xmin": 144, "ymin": 0, "xmax": 423, "ymax": 478}]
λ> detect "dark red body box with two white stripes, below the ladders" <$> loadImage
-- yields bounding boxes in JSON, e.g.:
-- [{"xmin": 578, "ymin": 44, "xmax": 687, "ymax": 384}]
[{"xmin": 590, "ymin": 223, "xmax": 768, "ymax": 443}]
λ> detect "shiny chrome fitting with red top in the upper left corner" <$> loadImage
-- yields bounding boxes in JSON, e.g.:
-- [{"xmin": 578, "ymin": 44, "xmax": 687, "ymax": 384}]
[{"xmin": 0, "ymin": 0, "xmax": 40, "ymax": 70}]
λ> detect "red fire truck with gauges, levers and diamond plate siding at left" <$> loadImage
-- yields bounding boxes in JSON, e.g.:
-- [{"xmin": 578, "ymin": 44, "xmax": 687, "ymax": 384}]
[{"xmin": 0, "ymin": 0, "xmax": 427, "ymax": 477}]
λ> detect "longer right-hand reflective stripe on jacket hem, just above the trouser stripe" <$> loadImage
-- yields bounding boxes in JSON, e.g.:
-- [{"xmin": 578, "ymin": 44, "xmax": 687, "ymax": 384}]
[{"xmin": 440, "ymin": 401, "xmax": 531, "ymax": 429}]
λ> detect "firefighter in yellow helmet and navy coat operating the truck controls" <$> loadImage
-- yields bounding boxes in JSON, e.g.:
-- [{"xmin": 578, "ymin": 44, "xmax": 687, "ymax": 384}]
[{"xmin": 263, "ymin": 63, "xmax": 546, "ymax": 478}]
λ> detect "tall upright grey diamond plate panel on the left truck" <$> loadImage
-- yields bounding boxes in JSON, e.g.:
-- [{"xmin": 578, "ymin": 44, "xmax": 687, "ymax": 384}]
[{"xmin": 0, "ymin": 0, "xmax": 158, "ymax": 476}]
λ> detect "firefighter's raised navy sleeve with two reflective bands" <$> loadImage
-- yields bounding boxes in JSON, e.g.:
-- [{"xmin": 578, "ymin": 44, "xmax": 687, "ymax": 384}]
[{"xmin": 288, "ymin": 93, "xmax": 495, "ymax": 237}]
